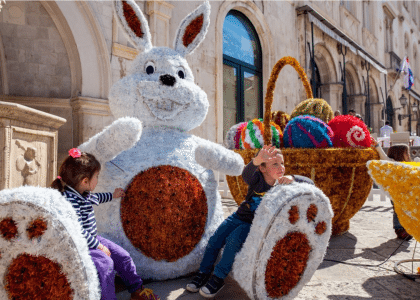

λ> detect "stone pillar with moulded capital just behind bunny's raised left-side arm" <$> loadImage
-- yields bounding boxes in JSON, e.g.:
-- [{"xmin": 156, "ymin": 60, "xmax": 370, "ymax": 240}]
[{"xmin": 70, "ymin": 97, "xmax": 114, "ymax": 147}]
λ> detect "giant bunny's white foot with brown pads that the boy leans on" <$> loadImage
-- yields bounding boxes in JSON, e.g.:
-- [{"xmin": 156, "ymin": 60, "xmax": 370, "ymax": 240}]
[{"xmin": 233, "ymin": 184, "xmax": 332, "ymax": 299}]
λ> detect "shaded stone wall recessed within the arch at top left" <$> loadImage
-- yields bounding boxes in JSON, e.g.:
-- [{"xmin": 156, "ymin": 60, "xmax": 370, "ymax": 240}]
[{"xmin": 0, "ymin": 1, "xmax": 71, "ymax": 98}]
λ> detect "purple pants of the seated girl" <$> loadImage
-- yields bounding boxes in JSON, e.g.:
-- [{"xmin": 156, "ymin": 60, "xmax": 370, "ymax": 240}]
[{"xmin": 89, "ymin": 235, "xmax": 143, "ymax": 300}]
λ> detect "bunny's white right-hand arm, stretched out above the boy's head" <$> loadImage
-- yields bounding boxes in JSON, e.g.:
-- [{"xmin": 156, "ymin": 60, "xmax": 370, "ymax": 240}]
[{"xmin": 195, "ymin": 140, "xmax": 244, "ymax": 176}]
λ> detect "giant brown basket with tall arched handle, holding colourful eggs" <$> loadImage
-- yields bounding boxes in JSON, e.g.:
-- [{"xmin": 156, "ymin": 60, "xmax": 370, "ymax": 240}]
[{"xmin": 226, "ymin": 56, "xmax": 379, "ymax": 235}]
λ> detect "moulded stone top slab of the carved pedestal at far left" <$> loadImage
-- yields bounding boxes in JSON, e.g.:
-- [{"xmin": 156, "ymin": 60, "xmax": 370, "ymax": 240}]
[{"xmin": 0, "ymin": 101, "xmax": 67, "ymax": 130}]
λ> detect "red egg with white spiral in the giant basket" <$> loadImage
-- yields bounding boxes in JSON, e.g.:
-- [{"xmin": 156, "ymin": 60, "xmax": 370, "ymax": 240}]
[{"xmin": 328, "ymin": 115, "xmax": 371, "ymax": 148}]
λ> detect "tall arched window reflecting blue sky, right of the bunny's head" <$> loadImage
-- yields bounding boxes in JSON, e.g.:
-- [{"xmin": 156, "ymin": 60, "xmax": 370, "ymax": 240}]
[{"xmin": 223, "ymin": 10, "xmax": 263, "ymax": 137}]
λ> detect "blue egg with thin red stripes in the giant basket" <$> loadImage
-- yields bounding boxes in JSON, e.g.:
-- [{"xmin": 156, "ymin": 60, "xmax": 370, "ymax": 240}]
[{"xmin": 283, "ymin": 115, "xmax": 334, "ymax": 148}]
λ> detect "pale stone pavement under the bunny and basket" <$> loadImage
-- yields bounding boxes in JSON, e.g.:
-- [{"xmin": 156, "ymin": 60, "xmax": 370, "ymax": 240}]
[{"xmin": 118, "ymin": 199, "xmax": 420, "ymax": 300}]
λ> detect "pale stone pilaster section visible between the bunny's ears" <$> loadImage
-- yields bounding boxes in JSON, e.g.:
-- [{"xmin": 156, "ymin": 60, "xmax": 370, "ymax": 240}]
[{"xmin": 146, "ymin": 1, "xmax": 174, "ymax": 47}]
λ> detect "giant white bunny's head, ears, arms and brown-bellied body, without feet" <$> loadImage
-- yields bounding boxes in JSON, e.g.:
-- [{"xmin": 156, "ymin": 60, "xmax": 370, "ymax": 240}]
[{"xmin": 79, "ymin": 1, "xmax": 244, "ymax": 280}]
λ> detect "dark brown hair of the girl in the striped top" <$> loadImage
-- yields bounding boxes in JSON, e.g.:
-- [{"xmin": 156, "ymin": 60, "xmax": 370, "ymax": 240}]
[{"xmin": 51, "ymin": 152, "xmax": 101, "ymax": 192}]
